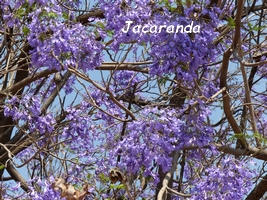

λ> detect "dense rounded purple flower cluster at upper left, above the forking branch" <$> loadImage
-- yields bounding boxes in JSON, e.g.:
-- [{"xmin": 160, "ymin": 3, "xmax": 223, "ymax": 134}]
[{"xmin": 28, "ymin": 7, "xmax": 103, "ymax": 70}]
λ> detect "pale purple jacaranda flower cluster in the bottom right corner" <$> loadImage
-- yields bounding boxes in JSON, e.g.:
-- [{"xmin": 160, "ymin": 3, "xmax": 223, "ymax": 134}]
[{"xmin": 191, "ymin": 157, "xmax": 255, "ymax": 200}]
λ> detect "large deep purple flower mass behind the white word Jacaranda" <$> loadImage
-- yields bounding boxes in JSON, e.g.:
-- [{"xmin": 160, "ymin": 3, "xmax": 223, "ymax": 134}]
[{"xmin": 100, "ymin": 1, "xmax": 220, "ymax": 77}]
